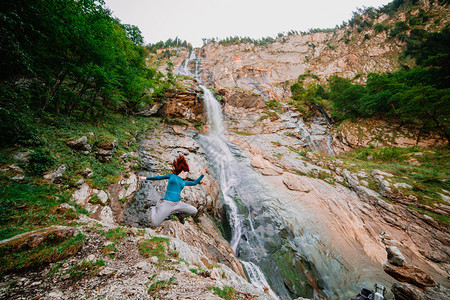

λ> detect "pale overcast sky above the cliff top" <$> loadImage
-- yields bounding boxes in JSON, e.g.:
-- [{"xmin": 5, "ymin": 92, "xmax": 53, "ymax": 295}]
[{"xmin": 105, "ymin": 0, "xmax": 392, "ymax": 47}]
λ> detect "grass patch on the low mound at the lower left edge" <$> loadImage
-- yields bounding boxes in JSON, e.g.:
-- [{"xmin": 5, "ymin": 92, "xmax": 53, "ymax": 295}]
[{"xmin": 0, "ymin": 233, "xmax": 85, "ymax": 274}]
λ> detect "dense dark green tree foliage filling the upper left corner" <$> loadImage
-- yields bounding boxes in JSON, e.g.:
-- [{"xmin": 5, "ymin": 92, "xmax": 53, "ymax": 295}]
[{"xmin": 0, "ymin": 0, "xmax": 172, "ymax": 131}]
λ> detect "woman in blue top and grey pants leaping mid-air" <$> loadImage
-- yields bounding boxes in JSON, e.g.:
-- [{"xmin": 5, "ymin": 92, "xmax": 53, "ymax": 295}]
[{"xmin": 139, "ymin": 155, "xmax": 206, "ymax": 227}]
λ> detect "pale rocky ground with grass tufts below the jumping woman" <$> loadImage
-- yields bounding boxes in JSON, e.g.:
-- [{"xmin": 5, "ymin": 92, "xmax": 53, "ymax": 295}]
[{"xmin": 0, "ymin": 217, "xmax": 267, "ymax": 299}]
